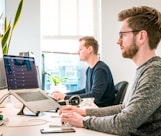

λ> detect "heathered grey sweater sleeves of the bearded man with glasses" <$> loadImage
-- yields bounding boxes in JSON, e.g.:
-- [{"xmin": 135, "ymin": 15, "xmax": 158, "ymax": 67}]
[{"xmin": 85, "ymin": 63, "xmax": 161, "ymax": 135}]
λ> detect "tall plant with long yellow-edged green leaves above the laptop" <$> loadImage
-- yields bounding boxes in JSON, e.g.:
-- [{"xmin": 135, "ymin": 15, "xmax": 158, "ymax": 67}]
[{"xmin": 0, "ymin": 0, "xmax": 23, "ymax": 54}]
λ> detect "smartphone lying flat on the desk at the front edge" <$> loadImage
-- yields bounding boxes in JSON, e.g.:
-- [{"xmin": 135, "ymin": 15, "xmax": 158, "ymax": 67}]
[{"xmin": 40, "ymin": 127, "xmax": 75, "ymax": 134}]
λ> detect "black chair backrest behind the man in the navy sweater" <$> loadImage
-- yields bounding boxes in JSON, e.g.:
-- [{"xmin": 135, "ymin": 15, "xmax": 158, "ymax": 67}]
[{"xmin": 114, "ymin": 81, "xmax": 129, "ymax": 105}]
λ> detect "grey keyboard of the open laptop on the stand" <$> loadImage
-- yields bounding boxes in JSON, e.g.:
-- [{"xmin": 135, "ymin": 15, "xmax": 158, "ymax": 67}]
[{"xmin": 17, "ymin": 91, "xmax": 48, "ymax": 102}]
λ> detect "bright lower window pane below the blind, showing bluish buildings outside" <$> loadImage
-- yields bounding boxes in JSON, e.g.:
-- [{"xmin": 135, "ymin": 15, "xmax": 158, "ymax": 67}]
[{"xmin": 42, "ymin": 53, "xmax": 87, "ymax": 92}]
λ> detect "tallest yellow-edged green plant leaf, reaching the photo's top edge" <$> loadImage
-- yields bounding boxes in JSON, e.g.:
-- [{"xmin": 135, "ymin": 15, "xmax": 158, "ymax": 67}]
[{"xmin": 12, "ymin": 0, "xmax": 23, "ymax": 30}]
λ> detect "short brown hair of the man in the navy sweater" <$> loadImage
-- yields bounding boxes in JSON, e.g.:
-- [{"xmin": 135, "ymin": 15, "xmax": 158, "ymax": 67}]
[{"xmin": 79, "ymin": 36, "xmax": 99, "ymax": 54}]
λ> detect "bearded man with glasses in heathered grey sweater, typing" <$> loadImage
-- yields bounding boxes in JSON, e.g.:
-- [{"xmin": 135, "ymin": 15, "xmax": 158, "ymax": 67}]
[{"xmin": 59, "ymin": 6, "xmax": 161, "ymax": 136}]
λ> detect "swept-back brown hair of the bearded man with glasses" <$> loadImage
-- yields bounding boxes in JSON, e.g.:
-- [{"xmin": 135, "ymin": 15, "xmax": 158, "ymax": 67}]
[{"xmin": 118, "ymin": 6, "xmax": 161, "ymax": 49}]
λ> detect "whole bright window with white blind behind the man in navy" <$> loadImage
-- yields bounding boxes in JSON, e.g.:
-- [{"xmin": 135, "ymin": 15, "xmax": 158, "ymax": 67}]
[{"xmin": 41, "ymin": 0, "xmax": 100, "ymax": 91}]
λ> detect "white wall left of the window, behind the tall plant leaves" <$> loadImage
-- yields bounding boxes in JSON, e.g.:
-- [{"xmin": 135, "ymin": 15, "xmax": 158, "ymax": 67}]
[{"xmin": 6, "ymin": 0, "xmax": 41, "ymax": 69}]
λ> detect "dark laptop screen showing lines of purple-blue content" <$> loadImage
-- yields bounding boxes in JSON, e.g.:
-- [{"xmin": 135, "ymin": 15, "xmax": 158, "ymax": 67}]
[{"xmin": 4, "ymin": 55, "xmax": 39, "ymax": 90}]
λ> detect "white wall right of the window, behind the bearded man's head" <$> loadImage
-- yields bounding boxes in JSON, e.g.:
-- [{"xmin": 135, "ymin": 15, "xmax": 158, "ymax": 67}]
[{"xmin": 101, "ymin": 0, "xmax": 161, "ymax": 87}]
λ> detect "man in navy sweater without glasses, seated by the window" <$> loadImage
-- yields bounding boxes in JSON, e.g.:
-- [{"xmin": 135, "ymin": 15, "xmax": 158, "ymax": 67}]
[{"xmin": 52, "ymin": 36, "xmax": 115, "ymax": 107}]
